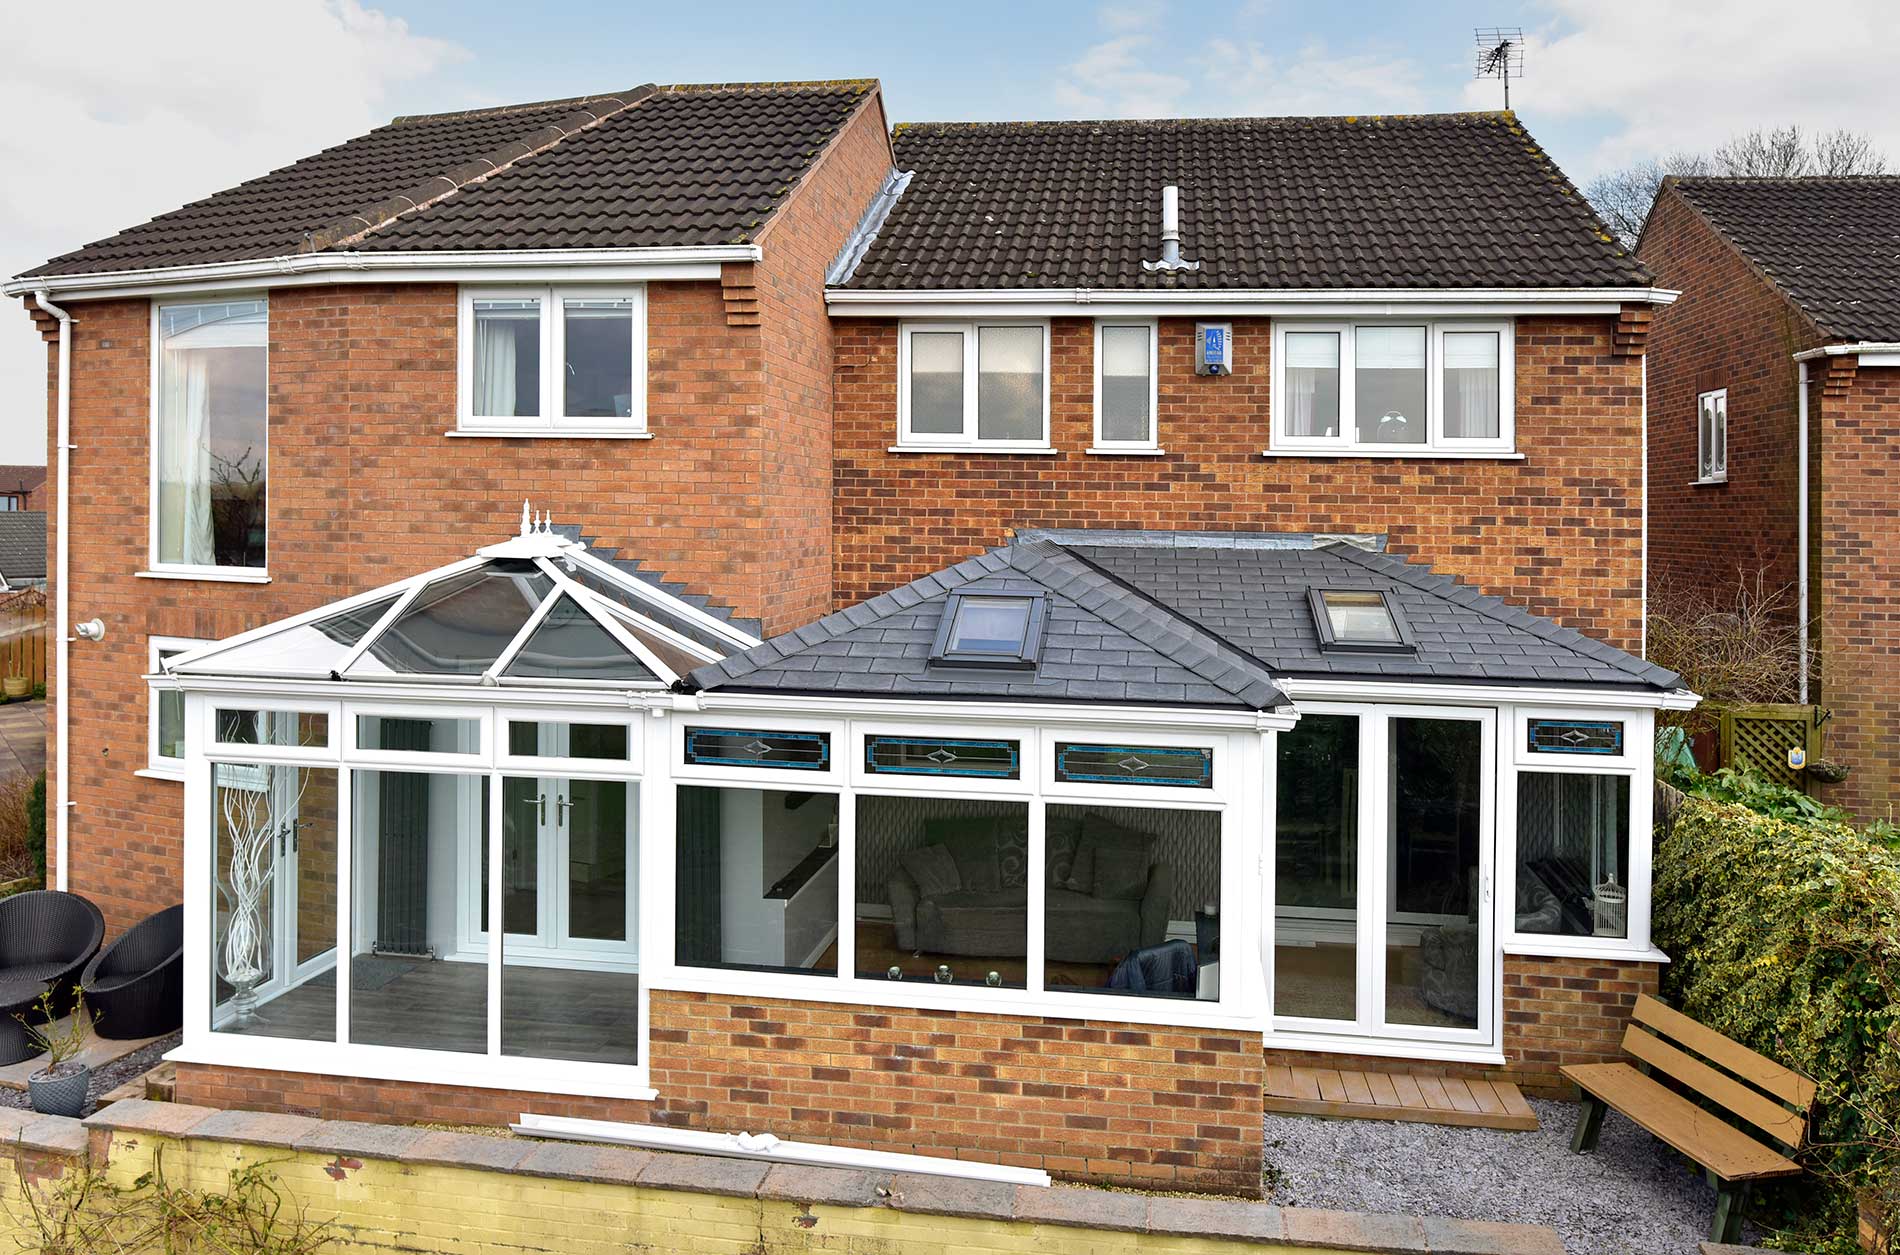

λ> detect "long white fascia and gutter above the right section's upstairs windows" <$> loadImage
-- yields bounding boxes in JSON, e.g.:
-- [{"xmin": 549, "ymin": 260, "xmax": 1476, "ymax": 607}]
[{"xmin": 825, "ymin": 287, "xmax": 1680, "ymax": 317}]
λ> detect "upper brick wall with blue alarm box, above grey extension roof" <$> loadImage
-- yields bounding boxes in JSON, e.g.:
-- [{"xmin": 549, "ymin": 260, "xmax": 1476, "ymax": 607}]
[{"xmin": 834, "ymin": 317, "xmax": 1642, "ymax": 649}]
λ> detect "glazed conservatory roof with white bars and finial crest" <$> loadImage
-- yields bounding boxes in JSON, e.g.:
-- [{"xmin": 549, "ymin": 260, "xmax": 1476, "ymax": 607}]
[{"xmin": 167, "ymin": 511, "xmax": 758, "ymax": 687}]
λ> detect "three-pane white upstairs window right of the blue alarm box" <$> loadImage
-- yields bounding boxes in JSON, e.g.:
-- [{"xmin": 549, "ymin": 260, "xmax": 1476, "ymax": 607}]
[{"xmin": 1267, "ymin": 319, "xmax": 1516, "ymax": 456}]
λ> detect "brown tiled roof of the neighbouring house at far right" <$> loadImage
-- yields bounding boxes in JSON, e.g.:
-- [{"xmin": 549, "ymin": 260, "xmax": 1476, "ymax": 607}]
[{"xmin": 1672, "ymin": 175, "xmax": 1900, "ymax": 344}]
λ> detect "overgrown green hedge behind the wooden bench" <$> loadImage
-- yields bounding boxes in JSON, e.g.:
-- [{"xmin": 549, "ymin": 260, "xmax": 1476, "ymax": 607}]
[{"xmin": 1655, "ymin": 797, "xmax": 1900, "ymax": 1198}]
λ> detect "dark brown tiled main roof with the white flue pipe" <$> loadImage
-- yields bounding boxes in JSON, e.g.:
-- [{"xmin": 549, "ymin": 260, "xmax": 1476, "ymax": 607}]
[{"xmin": 846, "ymin": 114, "xmax": 1649, "ymax": 289}]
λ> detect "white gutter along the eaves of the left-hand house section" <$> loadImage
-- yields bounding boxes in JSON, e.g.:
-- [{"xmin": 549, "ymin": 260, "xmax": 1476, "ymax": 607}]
[{"xmin": 0, "ymin": 245, "xmax": 764, "ymax": 298}]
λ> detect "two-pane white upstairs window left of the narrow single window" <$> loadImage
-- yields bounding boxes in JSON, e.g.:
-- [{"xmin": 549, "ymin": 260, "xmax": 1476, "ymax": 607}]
[{"xmin": 897, "ymin": 323, "xmax": 1049, "ymax": 452}]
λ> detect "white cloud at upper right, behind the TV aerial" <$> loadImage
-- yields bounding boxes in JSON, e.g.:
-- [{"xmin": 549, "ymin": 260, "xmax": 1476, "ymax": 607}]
[{"xmin": 1465, "ymin": 0, "xmax": 1900, "ymax": 180}]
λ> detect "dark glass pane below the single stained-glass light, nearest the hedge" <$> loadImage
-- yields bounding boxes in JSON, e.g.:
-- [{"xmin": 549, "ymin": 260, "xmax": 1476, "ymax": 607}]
[{"xmin": 1516, "ymin": 771, "xmax": 1630, "ymax": 938}]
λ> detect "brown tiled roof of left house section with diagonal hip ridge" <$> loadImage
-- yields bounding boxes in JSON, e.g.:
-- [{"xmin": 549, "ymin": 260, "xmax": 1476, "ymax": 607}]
[{"xmin": 23, "ymin": 80, "xmax": 876, "ymax": 277}]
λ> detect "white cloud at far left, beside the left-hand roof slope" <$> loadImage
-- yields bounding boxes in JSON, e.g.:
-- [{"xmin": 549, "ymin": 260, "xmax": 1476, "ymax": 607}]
[{"xmin": 0, "ymin": 0, "xmax": 469, "ymax": 461}]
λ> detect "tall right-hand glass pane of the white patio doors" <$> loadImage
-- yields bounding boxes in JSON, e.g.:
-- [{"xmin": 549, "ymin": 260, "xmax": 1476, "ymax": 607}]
[{"xmin": 1385, "ymin": 720, "xmax": 1488, "ymax": 1029}]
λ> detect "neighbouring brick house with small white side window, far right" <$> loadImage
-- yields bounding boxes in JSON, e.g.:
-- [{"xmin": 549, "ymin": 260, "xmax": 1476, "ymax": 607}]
[{"xmin": 1638, "ymin": 177, "xmax": 1900, "ymax": 818}]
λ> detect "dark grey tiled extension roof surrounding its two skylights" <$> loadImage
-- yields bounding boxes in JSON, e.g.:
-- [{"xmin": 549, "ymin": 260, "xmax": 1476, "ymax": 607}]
[{"xmin": 682, "ymin": 532, "xmax": 1678, "ymax": 710}]
